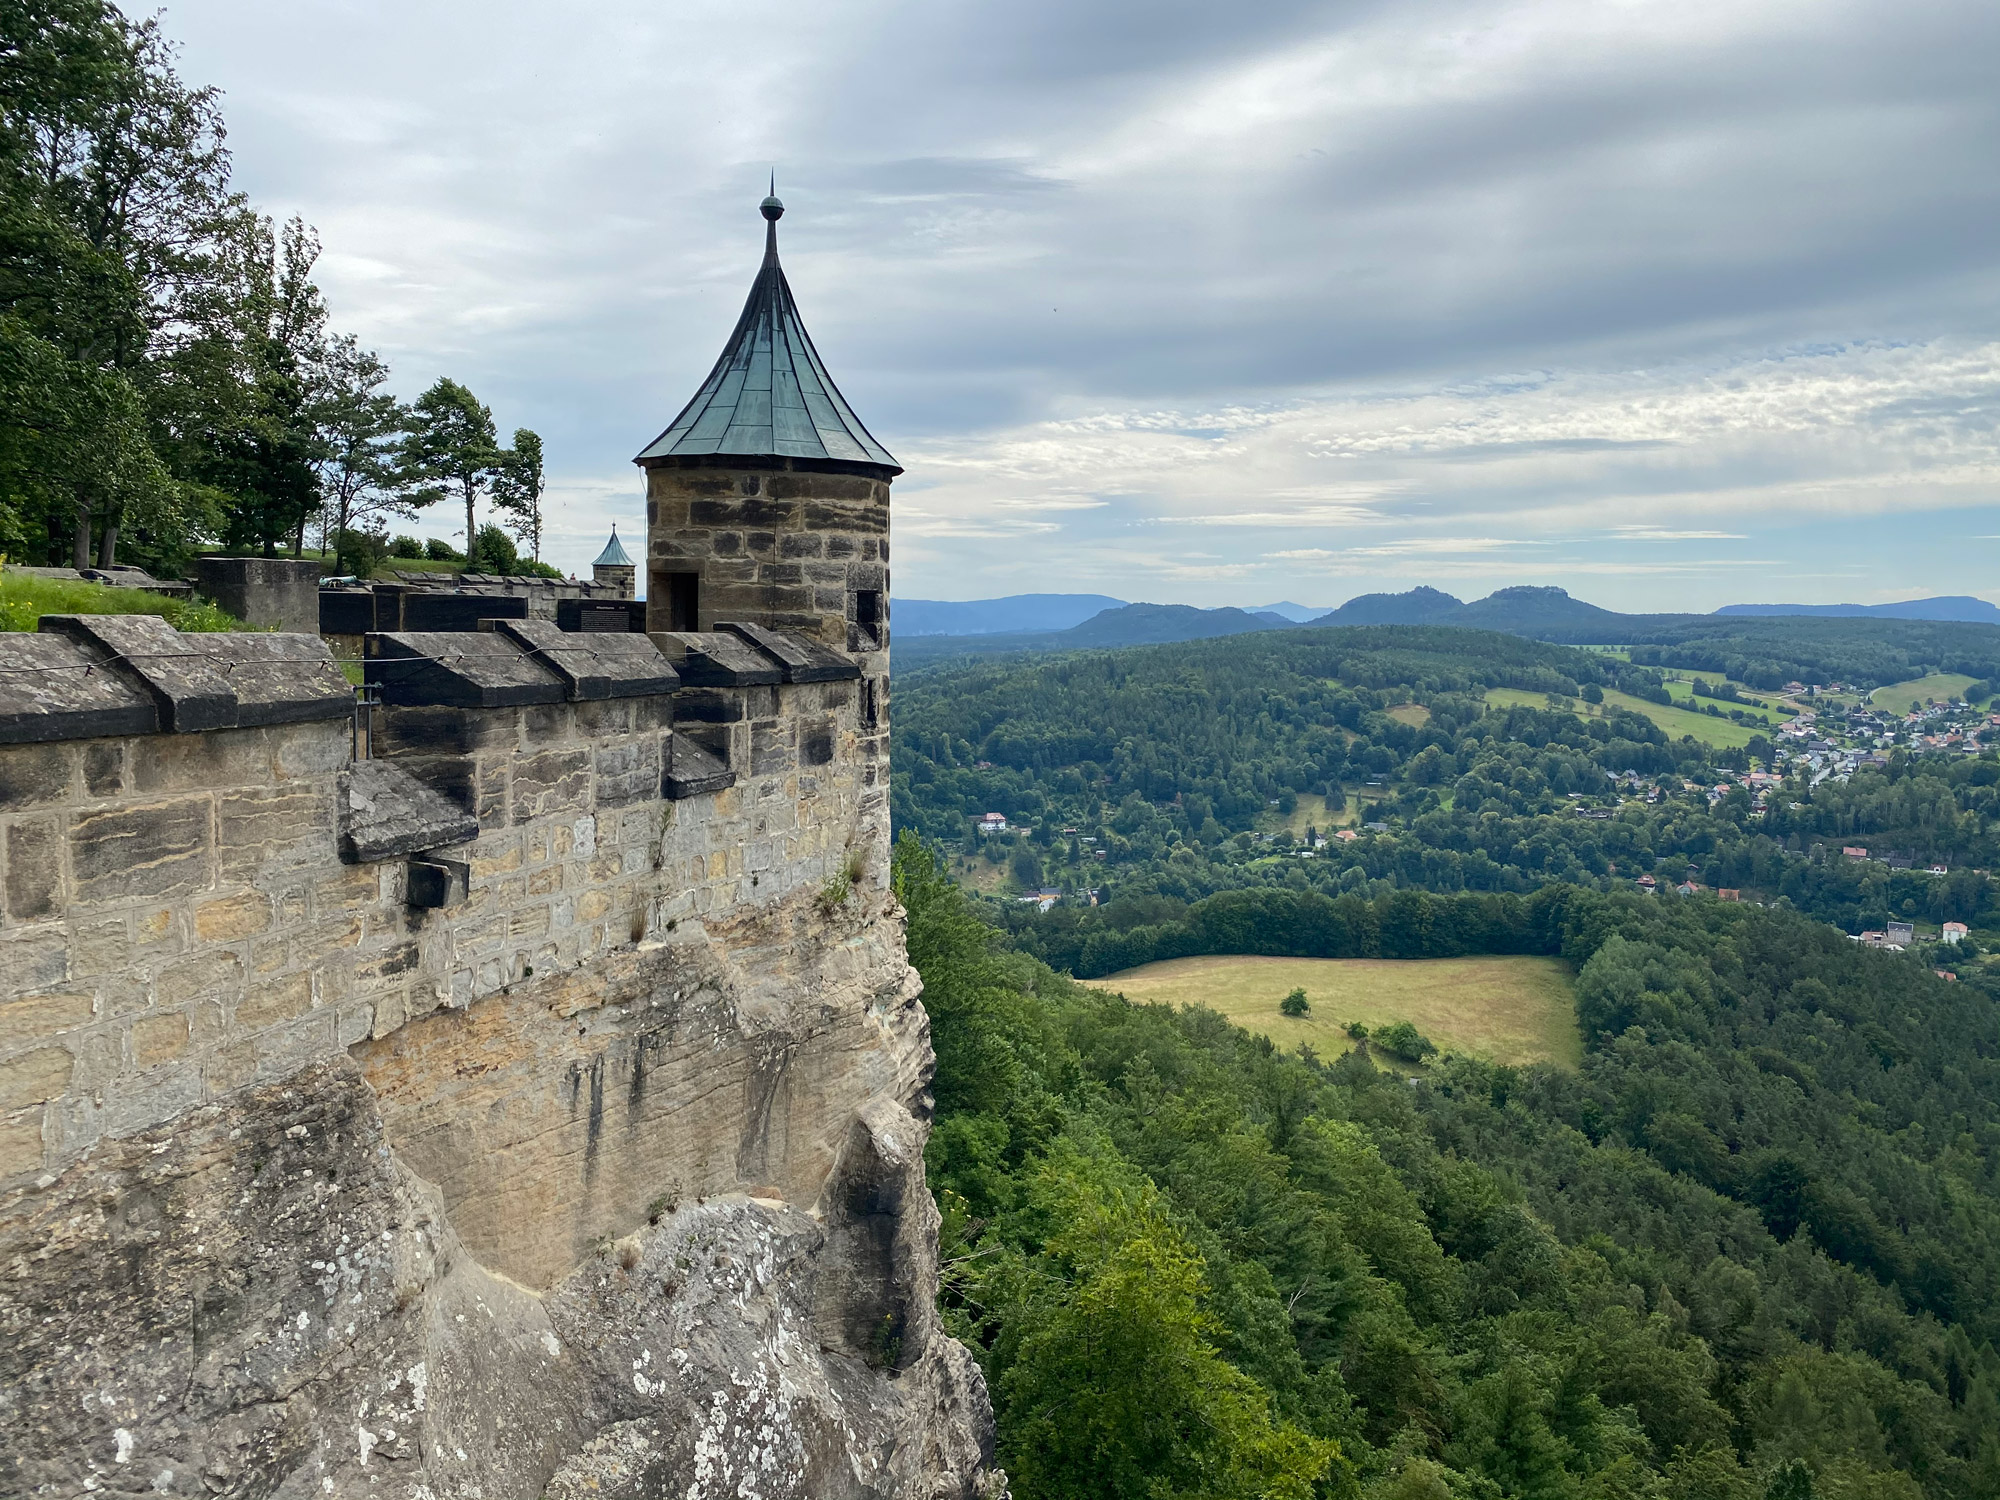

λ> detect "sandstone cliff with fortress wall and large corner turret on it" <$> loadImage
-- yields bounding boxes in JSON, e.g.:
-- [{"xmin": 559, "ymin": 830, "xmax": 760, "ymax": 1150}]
[{"xmin": 0, "ymin": 200, "xmax": 1004, "ymax": 1500}]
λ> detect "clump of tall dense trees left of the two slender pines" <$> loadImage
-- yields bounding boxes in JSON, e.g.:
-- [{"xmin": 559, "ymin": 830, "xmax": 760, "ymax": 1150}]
[{"xmin": 0, "ymin": 0, "xmax": 450, "ymax": 572}]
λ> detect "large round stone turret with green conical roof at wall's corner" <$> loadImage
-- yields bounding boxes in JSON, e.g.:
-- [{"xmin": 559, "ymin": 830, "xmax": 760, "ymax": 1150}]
[{"xmin": 634, "ymin": 198, "xmax": 902, "ymax": 680}]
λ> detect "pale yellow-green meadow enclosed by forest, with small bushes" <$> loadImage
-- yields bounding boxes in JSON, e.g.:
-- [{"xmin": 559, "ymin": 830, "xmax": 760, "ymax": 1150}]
[{"xmin": 1094, "ymin": 956, "xmax": 1582, "ymax": 1066}]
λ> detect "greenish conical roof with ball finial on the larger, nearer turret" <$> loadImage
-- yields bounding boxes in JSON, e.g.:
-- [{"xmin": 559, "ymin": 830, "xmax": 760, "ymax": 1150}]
[{"xmin": 634, "ymin": 198, "xmax": 902, "ymax": 474}]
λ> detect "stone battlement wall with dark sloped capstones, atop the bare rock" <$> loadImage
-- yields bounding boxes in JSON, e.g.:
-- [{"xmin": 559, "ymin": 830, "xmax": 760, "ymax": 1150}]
[{"xmin": 0, "ymin": 616, "xmax": 888, "ymax": 1200}]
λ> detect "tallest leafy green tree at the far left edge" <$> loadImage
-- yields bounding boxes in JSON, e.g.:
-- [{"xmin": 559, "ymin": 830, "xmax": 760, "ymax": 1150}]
[{"xmin": 0, "ymin": 0, "xmax": 246, "ymax": 566}]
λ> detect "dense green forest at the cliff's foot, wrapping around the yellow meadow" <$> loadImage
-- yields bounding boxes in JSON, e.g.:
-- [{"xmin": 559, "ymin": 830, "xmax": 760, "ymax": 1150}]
[{"xmin": 894, "ymin": 834, "xmax": 2000, "ymax": 1500}]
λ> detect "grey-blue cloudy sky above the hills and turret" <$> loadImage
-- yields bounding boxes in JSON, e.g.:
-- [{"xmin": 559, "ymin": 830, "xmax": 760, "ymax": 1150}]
[{"xmin": 166, "ymin": 0, "xmax": 2000, "ymax": 610}]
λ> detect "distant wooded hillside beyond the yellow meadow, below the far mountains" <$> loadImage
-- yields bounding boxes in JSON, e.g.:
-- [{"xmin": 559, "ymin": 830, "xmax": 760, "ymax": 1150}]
[{"xmin": 892, "ymin": 620, "xmax": 2000, "ymax": 952}]
